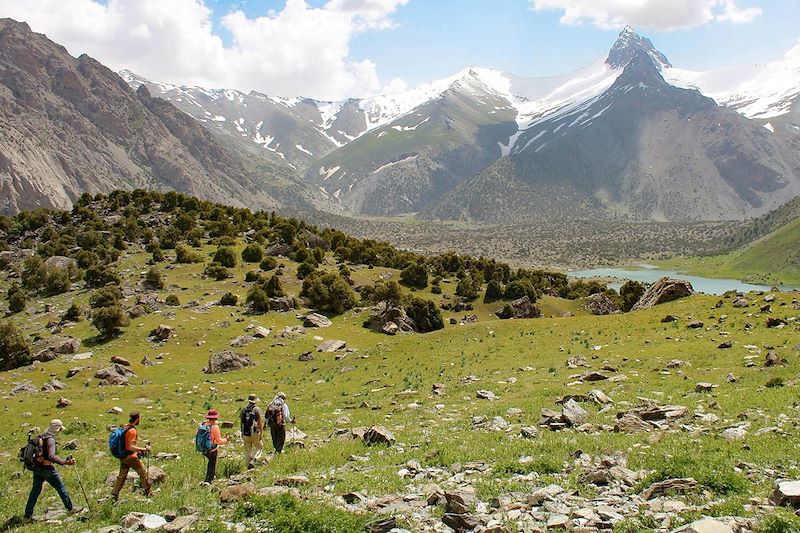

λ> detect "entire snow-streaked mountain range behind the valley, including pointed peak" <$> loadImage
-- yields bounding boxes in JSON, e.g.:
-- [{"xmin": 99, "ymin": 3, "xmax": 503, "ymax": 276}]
[{"xmin": 121, "ymin": 27, "xmax": 800, "ymax": 220}]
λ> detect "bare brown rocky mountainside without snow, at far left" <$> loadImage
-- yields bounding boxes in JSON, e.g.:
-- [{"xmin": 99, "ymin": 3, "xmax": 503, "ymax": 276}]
[{"xmin": 0, "ymin": 19, "xmax": 318, "ymax": 212}]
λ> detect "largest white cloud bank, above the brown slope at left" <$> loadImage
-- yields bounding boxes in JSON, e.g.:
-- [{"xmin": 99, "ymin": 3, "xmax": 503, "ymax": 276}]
[{"xmin": 0, "ymin": 0, "xmax": 408, "ymax": 99}]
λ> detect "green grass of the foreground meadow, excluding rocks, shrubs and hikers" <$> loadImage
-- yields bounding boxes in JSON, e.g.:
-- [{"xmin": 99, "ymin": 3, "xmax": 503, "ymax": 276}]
[{"xmin": 0, "ymin": 247, "xmax": 800, "ymax": 531}]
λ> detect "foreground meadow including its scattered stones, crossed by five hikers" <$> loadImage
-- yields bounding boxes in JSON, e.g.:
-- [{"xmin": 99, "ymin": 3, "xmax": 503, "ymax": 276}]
[{"xmin": 0, "ymin": 247, "xmax": 800, "ymax": 532}]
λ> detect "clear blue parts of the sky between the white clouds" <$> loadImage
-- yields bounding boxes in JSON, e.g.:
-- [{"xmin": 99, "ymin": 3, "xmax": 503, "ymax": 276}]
[{"xmin": 209, "ymin": 0, "xmax": 800, "ymax": 86}]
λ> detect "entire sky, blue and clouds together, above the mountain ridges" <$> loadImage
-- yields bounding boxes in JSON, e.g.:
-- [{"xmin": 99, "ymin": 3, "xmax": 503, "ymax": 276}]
[{"xmin": 0, "ymin": 0, "xmax": 800, "ymax": 99}]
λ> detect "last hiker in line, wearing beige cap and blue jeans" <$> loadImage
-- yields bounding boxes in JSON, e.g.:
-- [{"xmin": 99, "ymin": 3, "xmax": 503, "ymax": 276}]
[{"xmin": 25, "ymin": 418, "xmax": 81, "ymax": 522}]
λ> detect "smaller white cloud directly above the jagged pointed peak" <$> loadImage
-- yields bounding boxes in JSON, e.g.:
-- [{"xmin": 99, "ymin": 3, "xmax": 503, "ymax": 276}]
[{"xmin": 530, "ymin": 0, "xmax": 761, "ymax": 30}]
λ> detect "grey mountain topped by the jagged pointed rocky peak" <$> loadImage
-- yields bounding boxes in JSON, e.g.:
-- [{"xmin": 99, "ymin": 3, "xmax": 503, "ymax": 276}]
[{"xmin": 425, "ymin": 29, "xmax": 800, "ymax": 221}]
